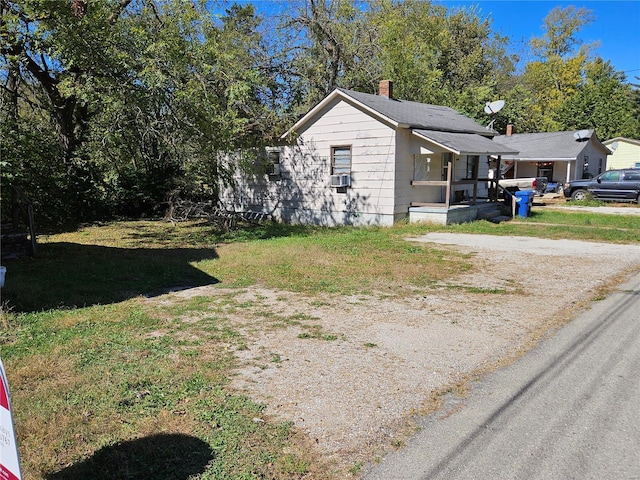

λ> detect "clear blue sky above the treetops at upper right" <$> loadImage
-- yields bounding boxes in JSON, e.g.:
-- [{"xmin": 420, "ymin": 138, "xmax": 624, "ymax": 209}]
[{"xmin": 438, "ymin": 0, "xmax": 640, "ymax": 83}]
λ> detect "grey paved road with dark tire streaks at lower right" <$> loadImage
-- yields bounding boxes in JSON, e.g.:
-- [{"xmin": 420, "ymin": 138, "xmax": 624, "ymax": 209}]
[{"xmin": 364, "ymin": 275, "xmax": 640, "ymax": 480}]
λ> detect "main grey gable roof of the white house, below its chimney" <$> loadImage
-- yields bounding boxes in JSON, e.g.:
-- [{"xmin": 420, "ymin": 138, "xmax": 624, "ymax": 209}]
[{"xmin": 282, "ymin": 88, "xmax": 497, "ymax": 138}]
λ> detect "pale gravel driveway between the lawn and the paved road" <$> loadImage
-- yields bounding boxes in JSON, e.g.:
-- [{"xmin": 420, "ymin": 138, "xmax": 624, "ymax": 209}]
[{"xmin": 172, "ymin": 233, "xmax": 640, "ymax": 478}]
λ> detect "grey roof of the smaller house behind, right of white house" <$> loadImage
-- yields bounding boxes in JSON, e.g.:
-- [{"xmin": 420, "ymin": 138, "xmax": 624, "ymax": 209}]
[{"xmin": 494, "ymin": 130, "xmax": 611, "ymax": 162}]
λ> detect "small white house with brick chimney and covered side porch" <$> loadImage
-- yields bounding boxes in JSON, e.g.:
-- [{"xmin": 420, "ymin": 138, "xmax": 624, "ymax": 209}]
[{"xmin": 224, "ymin": 81, "xmax": 515, "ymax": 226}]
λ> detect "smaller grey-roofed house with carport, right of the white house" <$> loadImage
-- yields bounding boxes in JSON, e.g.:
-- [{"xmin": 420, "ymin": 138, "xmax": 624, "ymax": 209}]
[{"xmin": 494, "ymin": 125, "xmax": 611, "ymax": 183}]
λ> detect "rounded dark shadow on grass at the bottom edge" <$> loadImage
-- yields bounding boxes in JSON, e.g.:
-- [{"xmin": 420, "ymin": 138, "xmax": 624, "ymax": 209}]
[{"xmin": 45, "ymin": 434, "xmax": 213, "ymax": 480}]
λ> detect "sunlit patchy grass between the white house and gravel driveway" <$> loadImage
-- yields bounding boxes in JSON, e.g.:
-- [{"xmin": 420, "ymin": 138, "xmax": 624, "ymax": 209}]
[{"xmin": 201, "ymin": 224, "xmax": 470, "ymax": 294}]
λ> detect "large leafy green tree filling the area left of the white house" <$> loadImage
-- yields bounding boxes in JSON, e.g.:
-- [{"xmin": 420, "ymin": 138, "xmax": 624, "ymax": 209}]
[{"xmin": 0, "ymin": 0, "xmax": 282, "ymax": 221}]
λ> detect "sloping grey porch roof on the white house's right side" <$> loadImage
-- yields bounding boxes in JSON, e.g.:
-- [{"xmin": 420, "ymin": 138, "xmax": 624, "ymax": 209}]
[{"xmin": 412, "ymin": 129, "xmax": 518, "ymax": 155}]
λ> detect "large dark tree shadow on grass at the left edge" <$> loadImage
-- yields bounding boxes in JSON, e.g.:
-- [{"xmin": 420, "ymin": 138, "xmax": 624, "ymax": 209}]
[{"xmin": 1, "ymin": 243, "xmax": 218, "ymax": 313}]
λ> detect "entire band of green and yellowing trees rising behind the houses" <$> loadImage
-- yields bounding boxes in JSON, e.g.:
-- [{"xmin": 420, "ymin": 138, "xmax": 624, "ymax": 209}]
[{"xmin": 0, "ymin": 0, "xmax": 640, "ymax": 228}]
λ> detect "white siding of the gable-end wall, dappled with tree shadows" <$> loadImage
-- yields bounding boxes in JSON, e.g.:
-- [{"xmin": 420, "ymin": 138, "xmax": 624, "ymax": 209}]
[{"xmin": 225, "ymin": 100, "xmax": 396, "ymax": 226}]
